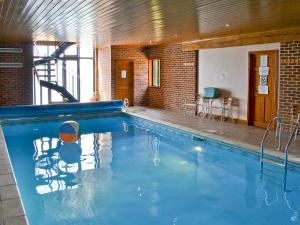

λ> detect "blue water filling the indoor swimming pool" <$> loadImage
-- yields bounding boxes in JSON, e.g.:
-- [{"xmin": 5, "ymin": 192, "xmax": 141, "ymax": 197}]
[{"xmin": 3, "ymin": 115, "xmax": 300, "ymax": 225}]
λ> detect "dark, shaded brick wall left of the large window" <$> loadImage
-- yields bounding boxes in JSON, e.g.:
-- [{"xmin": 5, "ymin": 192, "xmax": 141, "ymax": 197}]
[{"xmin": 0, "ymin": 42, "xmax": 33, "ymax": 105}]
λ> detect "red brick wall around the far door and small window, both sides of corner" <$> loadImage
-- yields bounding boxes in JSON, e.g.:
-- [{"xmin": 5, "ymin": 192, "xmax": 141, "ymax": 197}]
[{"xmin": 112, "ymin": 44, "xmax": 197, "ymax": 110}]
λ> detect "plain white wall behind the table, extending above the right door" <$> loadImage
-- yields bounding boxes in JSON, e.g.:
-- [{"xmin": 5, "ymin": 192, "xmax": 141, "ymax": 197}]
[{"xmin": 198, "ymin": 43, "xmax": 280, "ymax": 120}]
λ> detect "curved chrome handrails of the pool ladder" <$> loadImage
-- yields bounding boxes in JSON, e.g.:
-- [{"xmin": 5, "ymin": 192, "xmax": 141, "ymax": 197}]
[{"xmin": 260, "ymin": 116, "xmax": 299, "ymax": 177}]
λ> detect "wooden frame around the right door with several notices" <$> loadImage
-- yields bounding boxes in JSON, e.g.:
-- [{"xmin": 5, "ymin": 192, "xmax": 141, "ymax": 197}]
[{"xmin": 247, "ymin": 49, "xmax": 280, "ymax": 126}]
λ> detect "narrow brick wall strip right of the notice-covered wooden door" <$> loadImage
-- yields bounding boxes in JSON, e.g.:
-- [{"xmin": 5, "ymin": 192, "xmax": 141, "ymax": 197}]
[{"xmin": 279, "ymin": 41, "xmax": 300, "ymax": 119}]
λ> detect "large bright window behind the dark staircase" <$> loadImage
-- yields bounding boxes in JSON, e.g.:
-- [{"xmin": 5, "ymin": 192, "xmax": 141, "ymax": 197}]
[{"xmin": 32, "ymin": 43, "xmax": 95, "ymax": 105}]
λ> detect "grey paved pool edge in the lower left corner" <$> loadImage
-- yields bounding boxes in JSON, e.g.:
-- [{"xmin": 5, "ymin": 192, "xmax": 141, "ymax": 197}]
[{"xmin": 0, "ymin": 125, "xmax": 29, "ymax": 225}]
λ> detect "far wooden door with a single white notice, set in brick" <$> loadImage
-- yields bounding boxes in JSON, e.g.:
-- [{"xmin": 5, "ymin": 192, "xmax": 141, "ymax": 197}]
[{"xmin": 115, "ymin": 60, "xmax": 134, "ymax": 106}]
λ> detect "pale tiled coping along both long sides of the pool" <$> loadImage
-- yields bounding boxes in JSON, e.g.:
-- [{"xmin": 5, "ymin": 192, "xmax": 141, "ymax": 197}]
[{"xmin": 0, "ymin": 112, "xmax": 300, "ymax": 225}]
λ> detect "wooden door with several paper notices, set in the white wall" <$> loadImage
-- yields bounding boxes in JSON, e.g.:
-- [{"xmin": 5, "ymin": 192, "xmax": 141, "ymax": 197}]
[{"xmin": 248, "ymin": 50, "xmax": 278, "ymax": 128}]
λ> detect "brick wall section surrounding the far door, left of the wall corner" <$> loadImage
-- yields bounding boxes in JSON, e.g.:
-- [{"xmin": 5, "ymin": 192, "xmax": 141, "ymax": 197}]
[{"xmin": 111, "ymin": 46, "xmax": 148, "ymax": 105}]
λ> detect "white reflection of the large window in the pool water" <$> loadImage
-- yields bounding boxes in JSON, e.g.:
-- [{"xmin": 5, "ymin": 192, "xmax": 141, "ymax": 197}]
[{"xmin": 33, "ymin": 132, "xmax": 113, "ymax": 194}]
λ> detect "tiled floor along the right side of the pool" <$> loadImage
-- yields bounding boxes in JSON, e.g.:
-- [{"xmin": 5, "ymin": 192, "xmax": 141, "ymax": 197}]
[{"xmin": 128, "ymin": 107, "xmax": 300, "ymax": 163}]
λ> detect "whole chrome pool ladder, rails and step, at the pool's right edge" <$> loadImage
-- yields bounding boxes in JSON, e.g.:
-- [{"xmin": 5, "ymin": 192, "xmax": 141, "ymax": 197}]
[{"xmin": 260, "ymin": 116, "xmax": 299, "ymax": 186}]
